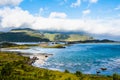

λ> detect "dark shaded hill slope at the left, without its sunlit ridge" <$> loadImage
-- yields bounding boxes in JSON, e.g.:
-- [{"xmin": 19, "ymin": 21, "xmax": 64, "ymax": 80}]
[{"xmin": 0, "ymin": 32, "xmax": 49, "ymax": 42}]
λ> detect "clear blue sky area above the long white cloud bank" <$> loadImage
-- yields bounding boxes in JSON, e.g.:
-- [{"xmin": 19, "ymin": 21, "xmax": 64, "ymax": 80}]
[{"xmin": 20, "ymin": 0, "xmax": 120, "ymax": 19}]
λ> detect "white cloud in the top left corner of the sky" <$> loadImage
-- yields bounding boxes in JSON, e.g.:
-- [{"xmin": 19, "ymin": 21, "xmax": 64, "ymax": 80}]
[{"xmin": 0, "ymin": 0, "xmax": 23, "ymax": 6}]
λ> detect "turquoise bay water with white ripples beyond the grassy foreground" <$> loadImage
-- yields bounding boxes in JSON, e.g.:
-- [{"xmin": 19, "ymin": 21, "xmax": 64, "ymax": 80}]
[{"xmin": 35, "ymin": 44, "xmax": 120, "ymax": 75}]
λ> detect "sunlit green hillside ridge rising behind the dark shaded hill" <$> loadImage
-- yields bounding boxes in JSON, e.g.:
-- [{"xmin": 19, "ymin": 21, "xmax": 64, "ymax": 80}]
[{"xmin": 10, "ymin": 28, "xmax": 93, "ymax": 41}]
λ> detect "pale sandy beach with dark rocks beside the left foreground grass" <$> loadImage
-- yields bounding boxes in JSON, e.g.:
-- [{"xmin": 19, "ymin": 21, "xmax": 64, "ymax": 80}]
[{"xmin": 1, "ymin": 49, "xmax": 53, "ymax": 65}]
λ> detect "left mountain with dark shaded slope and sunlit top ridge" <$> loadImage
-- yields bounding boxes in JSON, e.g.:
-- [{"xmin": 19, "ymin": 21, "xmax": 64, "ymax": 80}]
[{"xmin": 0, "ymin": 28, "xmax": 49, "ymax": 42}]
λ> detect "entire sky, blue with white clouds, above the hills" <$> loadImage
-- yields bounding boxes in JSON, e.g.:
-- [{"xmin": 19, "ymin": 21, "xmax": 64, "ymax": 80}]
[{"xmin": 0, "ymin": 0, "xmax": 120, "ymax": 40}]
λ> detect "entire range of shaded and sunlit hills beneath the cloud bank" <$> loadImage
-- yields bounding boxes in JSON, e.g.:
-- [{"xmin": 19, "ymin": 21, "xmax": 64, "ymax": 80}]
[{"xmin": 0, "ymin": 28, "xmax": 94, "ymax": 42}]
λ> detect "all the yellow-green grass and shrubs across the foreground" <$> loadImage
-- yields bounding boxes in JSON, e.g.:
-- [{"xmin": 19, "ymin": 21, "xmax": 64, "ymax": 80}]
[{"xmin": 0, "ymin": 52, "xmax": 120, "ymax": 80}]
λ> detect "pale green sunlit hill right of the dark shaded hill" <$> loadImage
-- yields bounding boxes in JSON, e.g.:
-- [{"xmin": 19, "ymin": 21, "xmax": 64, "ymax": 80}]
[{"xmin": 44, "ymin": 33, "xmax": 93, "ymax": 41}]
